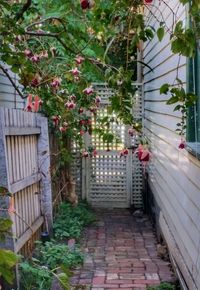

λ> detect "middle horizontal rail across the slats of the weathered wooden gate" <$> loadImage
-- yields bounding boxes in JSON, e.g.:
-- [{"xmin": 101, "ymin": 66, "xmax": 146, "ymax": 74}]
[{"xmin": 10, "ymin": 173, "xmax": 42, "ymax": 193}]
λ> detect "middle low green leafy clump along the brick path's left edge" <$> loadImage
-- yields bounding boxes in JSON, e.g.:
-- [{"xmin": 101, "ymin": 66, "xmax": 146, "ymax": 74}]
[{"xmin": 36, "ymin": 241, "xmax": 83, "ymax": 270}]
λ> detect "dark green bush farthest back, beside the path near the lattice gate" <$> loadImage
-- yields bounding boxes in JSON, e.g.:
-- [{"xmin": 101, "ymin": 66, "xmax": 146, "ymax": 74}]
[{"xmin": 53, "ymin": 202, "xmax": 95, "ymax": 240}]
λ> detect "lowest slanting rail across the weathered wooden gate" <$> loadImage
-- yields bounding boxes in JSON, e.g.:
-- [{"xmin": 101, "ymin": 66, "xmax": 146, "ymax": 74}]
[{"xmin": 15, "ymin": 216, "xmax": 44, "ymax": 253}]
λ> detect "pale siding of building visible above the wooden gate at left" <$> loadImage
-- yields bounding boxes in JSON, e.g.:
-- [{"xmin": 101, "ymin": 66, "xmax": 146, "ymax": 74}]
[{"xmin": 0, "ymin": 64, "xmax": 24, "ymax": 109}]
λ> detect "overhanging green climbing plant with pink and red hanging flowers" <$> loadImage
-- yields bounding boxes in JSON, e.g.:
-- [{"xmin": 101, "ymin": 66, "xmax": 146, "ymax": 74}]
[{"xmin": 0, "ymin": 0, "xmax": 200, "ymax": 282}]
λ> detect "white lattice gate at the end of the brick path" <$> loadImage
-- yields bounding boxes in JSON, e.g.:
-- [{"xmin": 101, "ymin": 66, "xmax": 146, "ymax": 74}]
[{"xmin": 82, "ymin": 84, "xmax": 143, "ymax": 208}]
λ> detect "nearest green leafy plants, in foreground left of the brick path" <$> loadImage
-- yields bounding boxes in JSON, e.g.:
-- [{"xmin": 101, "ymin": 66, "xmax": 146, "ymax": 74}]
[{"xmin": 20, "ymin": 241, "xmax": 83, "ymax": 290}]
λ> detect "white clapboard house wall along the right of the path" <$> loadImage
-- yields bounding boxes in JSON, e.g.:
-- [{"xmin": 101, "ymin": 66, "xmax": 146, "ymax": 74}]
[{"xmin": 143, "ymin": 0, "xmax": 200, "ymax": 290}]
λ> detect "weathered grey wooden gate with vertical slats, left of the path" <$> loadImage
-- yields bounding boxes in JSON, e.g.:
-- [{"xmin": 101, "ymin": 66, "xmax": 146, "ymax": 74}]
[{"xmin": 0, "ymin": 108, "xmax": 52, "ymax": 255}]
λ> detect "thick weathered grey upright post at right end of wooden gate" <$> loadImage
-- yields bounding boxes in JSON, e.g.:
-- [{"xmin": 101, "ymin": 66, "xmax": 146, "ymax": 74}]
[{"xmin": 37, "ymin": 116, "xmax": 53, "ymax": 231}]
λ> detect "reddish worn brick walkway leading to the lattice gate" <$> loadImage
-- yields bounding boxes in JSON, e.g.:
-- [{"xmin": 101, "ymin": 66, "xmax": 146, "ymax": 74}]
[{"xmin": 71, "ymin": 209, "xmax": 172, "ymax": 290}]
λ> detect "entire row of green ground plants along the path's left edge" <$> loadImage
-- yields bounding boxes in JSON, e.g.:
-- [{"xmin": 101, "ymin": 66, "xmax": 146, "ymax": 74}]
[{"xmin": 20, "ymin": 202, "xmax": 95, "ymax": 290}]
